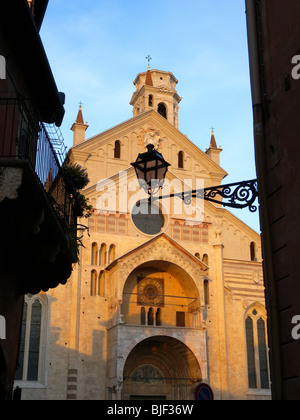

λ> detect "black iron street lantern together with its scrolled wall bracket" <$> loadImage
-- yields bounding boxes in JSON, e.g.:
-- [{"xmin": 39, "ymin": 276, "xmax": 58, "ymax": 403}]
[{"xmin": 131, "ymin": 144, "xmax": 258, "ymax": 213}]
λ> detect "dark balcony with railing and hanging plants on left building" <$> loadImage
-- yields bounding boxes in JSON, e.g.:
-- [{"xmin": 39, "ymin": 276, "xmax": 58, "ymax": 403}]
[{"xmin": 0, "ymin": 95, "xmax": 81, "ymax": 293}]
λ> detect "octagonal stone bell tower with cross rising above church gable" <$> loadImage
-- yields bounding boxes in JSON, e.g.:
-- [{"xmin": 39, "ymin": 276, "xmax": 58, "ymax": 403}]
[{"xmin": 130, "ymin": 61, "xmax": 182, "ymax": 129}]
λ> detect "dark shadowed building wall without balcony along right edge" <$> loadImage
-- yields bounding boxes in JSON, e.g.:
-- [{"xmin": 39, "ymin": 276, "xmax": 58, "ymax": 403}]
[{"xmin": 246, "ymin": 0, "xmax": 300, "ymax": 400}]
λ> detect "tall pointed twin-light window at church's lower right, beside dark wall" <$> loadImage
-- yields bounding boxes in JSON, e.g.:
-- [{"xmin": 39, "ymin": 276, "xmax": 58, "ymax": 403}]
[{"xmin": 245, "ymin": 308, "xmax": 270, "ymax": 390}]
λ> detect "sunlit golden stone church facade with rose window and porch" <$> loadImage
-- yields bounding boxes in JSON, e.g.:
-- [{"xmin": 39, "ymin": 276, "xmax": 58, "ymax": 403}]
[{"xmin": 15, "ymin": 68, "xmax": 270, "ymax": 400}]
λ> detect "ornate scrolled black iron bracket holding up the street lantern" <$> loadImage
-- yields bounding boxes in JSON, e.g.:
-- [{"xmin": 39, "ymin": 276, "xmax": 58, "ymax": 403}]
[{"xmin": 152, "ymin": 179, "xmax": 258, "ymax": 213}]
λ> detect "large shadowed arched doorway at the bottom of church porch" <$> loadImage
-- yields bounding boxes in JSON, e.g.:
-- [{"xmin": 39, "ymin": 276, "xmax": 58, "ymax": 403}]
[{"xmin": 123, "ymin": 336, "xmax": 202, "ymax": 400}]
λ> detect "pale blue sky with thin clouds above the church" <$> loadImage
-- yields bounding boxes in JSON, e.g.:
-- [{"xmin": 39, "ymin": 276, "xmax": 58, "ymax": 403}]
[{"xmin": 41, "ymin": 0, "xmax": 259, "ymax": 231}]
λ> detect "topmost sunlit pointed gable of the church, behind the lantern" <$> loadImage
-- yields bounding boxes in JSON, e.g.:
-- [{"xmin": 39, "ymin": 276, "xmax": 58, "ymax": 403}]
[{"xmin": 69, "ymin": 110, "xmax": 227, "ymax": 191}]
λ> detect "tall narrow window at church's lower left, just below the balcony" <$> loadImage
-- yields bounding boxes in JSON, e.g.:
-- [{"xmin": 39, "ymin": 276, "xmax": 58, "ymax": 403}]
[{"xmin": 15, "ymin": 295, "xmax": 47, "ymax": 383}]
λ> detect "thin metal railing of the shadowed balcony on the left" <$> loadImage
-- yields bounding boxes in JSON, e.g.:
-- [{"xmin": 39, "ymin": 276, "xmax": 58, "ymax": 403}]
[{"xmin": 0, "ymin": 97, "xmax": 80, "ymax": 226}]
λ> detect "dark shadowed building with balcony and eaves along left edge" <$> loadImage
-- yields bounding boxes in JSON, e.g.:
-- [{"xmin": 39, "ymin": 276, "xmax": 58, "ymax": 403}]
[{"xmin": 0, "ymin": 0, "xmax": 80, "ymax": 400}]
